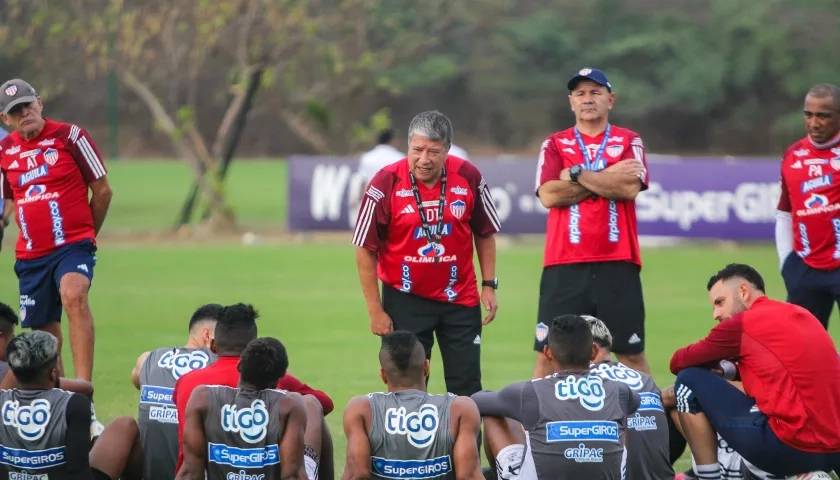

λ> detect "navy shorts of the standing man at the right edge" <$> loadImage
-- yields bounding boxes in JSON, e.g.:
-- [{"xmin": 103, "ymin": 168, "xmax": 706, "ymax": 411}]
[{"xmin": 782, "ymin": 253, "xmax": 840, "ymax": 328}]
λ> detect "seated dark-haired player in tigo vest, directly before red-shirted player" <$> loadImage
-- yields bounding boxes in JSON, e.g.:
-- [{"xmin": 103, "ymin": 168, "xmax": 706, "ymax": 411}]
[{"xmin": 176, "ymin": 338, "xmax": 320, "ymax": 480}]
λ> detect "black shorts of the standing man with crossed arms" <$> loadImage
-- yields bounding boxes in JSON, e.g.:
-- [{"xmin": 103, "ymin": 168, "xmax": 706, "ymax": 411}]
[{"xmin": 534, "ymin": 262, "xmax": 645, "ymax": 354}]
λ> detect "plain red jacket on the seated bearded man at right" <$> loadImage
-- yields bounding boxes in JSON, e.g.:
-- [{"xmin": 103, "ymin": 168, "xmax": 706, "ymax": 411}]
[{"xmin": 671, "ymin": 297, "xmax": 840, "ymax": 453}]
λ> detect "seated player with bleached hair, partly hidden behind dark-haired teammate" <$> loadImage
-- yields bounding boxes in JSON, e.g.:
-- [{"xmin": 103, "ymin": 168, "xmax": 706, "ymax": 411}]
[{"xmin": 582, "ymin": 315, "xmax": 674, "ymax": 480}]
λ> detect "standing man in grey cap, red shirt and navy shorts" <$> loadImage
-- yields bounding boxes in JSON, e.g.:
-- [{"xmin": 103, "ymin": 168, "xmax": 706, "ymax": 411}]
[{"xmin": 0, "ymin": 79, "xmax": 113, "ymax": 382}]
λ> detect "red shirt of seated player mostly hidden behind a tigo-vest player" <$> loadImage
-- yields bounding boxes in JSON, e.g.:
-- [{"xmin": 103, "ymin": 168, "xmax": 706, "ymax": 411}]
[{"xmin": 172, "ymin": 357, "xmax": 335, "ymax": 475}]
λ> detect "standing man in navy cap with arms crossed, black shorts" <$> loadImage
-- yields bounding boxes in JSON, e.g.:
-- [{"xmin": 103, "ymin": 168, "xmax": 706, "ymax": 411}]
[{"xmin": 534, "ymin": 68, "xmax": 650, "ymax": 378}]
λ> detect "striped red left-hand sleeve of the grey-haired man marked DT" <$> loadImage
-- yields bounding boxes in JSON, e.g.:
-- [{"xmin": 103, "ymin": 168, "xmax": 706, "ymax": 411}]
[{"xmin": 353, "ymin": 170, "xmax": 394, "ymax": 252}]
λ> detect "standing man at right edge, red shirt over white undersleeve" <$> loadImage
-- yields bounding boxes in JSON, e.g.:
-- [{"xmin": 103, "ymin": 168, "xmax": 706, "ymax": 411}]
[{"xmin": 776, "ymin": 84, "xmax": 840, "ymax": 328}]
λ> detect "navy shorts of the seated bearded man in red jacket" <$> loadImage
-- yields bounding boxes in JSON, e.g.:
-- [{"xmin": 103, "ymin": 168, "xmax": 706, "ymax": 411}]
[{"xmin": 674, "ymin": 368, "xmax": 840, "ymax": 476}]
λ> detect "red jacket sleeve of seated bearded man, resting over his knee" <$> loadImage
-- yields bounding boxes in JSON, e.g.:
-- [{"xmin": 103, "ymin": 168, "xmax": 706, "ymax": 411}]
[{"xmin": 671, "ymin": 315, "xmax": 743, "ymax": 375}]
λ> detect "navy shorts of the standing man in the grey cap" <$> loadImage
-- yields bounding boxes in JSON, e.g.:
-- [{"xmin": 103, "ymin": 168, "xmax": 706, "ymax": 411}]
[{"xmin": 15, "ymin": 240, "xmax": 96, "ymax": 328}]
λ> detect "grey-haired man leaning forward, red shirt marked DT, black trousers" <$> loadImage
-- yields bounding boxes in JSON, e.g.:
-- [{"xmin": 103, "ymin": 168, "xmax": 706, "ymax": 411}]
[{"xmin": 353, "ymin": 112, "xmax": 501, "ymax": 396}]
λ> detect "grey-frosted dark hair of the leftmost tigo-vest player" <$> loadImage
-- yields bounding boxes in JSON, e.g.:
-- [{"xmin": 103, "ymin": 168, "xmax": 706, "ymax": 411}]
[{"xmin": 6, "ymin": 330, "xmax": 58, "ymax": 384}]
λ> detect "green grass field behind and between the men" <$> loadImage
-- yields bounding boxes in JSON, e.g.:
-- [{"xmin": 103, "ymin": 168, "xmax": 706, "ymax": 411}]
[{"xmin": 0, "ymin": 161, "xmax": 840, "ymax": 473}]
